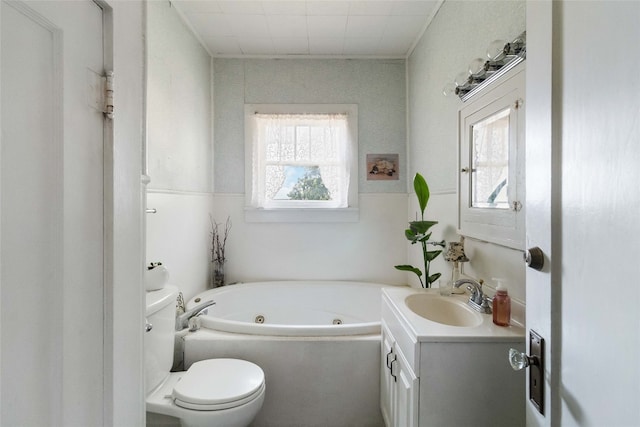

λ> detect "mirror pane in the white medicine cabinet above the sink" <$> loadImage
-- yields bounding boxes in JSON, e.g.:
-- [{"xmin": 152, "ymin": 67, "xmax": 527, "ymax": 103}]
[{"xmin": 471, "ymin": 109, "xmax": 511, "ymax": 209}]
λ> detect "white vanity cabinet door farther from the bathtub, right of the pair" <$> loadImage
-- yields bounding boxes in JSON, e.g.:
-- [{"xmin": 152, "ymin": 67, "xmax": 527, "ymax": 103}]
[{"xmin": 393, "ymin": 349, "xmax": 419, "ymax": 427}]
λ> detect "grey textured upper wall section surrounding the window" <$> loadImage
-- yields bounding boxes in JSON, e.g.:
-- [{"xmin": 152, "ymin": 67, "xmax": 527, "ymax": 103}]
[{"xmin": 214, "ymin": 58, "xmax": 406, "ymax": 193}]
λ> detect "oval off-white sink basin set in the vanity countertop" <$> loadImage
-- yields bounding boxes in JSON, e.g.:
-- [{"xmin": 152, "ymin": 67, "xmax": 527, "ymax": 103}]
[{"xmin": 404, "ymin": 294, "xmax": 482, "ymax": 328}]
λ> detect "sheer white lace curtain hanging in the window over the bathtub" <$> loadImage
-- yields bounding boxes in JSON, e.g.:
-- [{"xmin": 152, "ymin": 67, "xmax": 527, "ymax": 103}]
[{"xmin": 251, "ymin": 113, "xmax": 352, "ymax": 208}]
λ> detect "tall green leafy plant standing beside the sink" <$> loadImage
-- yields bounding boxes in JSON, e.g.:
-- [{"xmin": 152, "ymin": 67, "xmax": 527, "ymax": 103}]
[{"xmin": 395, "ymin": 173, "xmax": 445, "ymax": 288}]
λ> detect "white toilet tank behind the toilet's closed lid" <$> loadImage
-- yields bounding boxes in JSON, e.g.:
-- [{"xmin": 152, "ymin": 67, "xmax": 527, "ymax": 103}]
[{"xmin": 144, "ymin": 285, "xmax": 178, "ymax": 395}]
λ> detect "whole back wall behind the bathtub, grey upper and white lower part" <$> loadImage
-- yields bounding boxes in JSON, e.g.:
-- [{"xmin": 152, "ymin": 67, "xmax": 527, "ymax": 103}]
[{"xmin": 214, "ymin": 58, "xmax": 409, "ymax": 290}]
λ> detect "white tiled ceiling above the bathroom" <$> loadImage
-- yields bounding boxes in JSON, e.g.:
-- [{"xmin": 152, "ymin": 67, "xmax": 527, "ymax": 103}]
[{"xmin": 171, "ymin": 0, "xmax": 443, "ymax": 58}]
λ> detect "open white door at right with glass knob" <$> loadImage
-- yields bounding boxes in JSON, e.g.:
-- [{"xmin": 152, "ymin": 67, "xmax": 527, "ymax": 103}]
[{"xmin": 526, "ymin": 1, "xmax": 640, "ymax": 427}]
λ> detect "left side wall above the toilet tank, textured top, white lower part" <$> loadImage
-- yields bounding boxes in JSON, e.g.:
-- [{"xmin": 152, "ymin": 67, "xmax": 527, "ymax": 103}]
[{"xmin": 146, "ymin": 1, "xmax": 213, "ymax": 298}]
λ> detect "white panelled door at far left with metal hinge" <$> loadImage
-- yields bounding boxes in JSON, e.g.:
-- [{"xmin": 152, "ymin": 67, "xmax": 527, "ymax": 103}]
[{"xmin": 0, "ymin": 0, "xmax": 105, "ymax": 426}]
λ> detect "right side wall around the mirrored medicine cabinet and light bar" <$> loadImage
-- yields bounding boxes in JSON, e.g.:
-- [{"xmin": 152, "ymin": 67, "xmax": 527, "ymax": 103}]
[{"xmin": 408, "ymin": 1, "xmax": 525, "ymax": 302}]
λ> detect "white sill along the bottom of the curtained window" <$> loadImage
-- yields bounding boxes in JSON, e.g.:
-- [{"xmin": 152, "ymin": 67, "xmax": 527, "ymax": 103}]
[{"xmin": 244, "ymin": 207, "xmax": 360, "ymax": 223}]
